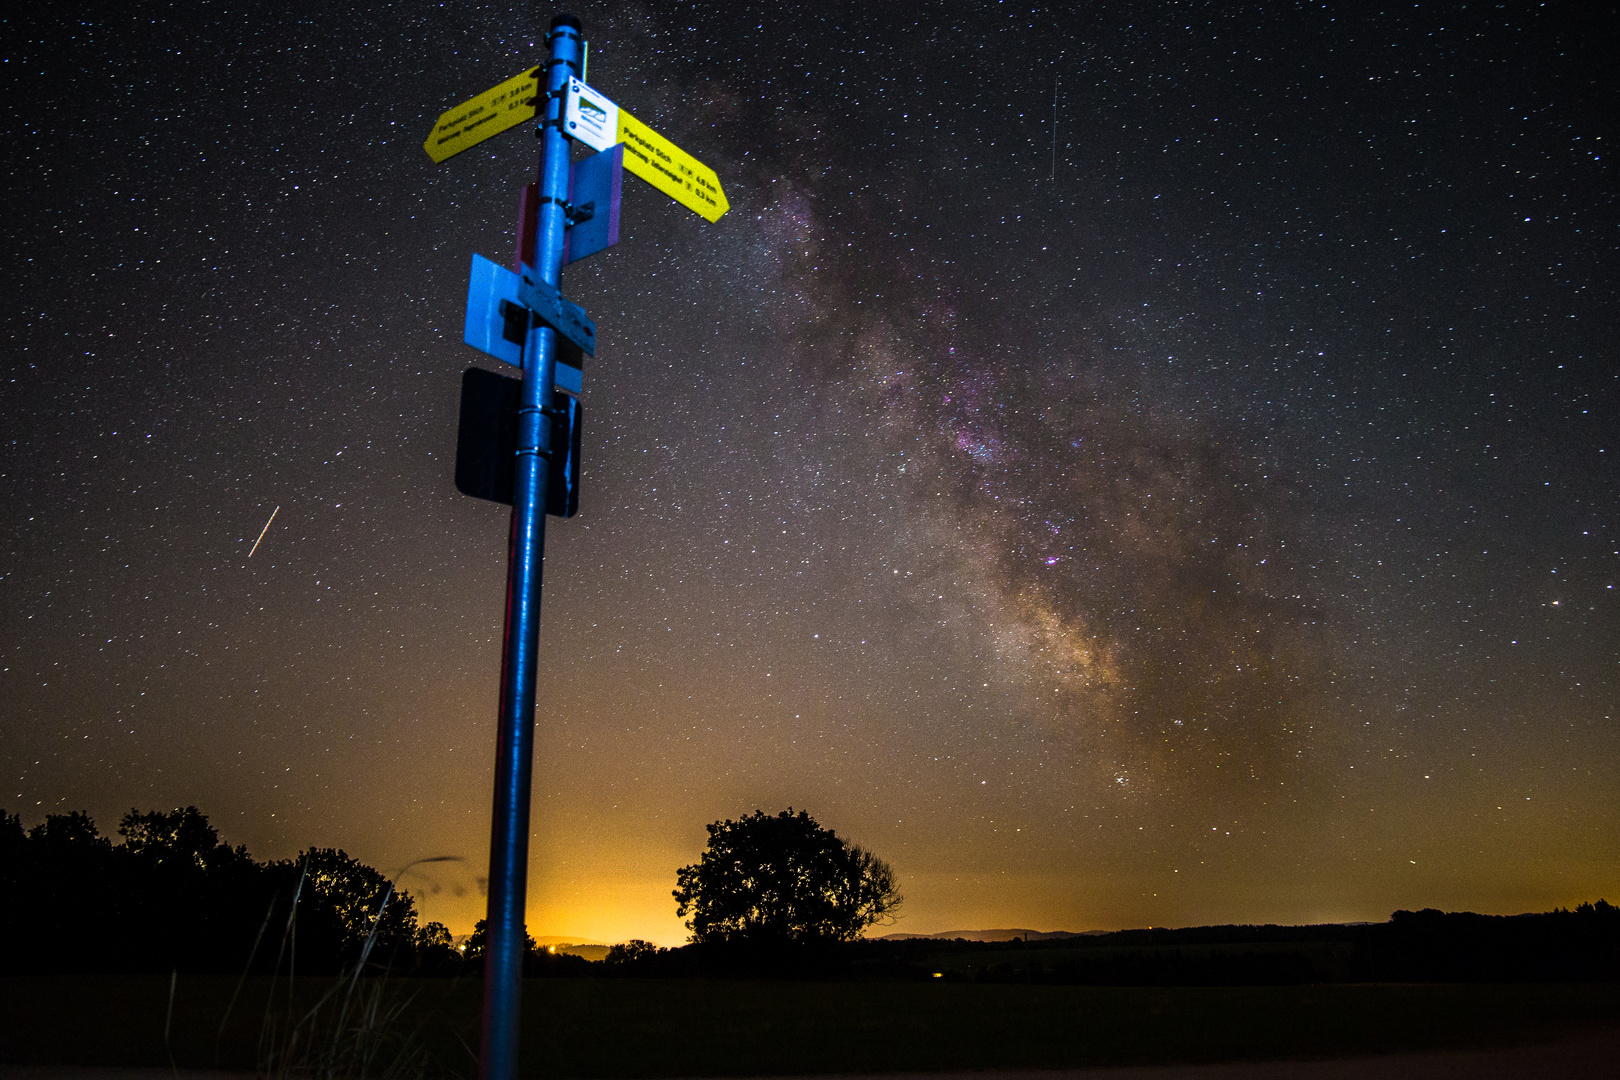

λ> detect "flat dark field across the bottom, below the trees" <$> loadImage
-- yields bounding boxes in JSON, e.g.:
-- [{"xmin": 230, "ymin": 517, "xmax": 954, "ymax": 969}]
[{"xmin": 0, "ymin": 975, "xmax": 1620, "ymax": 1077}]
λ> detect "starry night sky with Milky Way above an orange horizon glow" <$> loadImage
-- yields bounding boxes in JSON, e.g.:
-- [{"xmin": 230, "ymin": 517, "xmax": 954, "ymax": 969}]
[{"xmin": 0, "ymin": 0, "xmax": 1620, "ymax": 946}]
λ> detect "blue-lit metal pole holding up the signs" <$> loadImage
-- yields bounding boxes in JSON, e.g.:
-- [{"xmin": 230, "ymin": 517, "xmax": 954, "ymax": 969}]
[{"xmin": 478, "ymin": 15, "xmax": 582, "ymax": 1080}]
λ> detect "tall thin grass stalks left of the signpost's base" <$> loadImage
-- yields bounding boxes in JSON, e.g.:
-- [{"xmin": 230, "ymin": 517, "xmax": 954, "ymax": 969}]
[{"xmin": 221, "ymin": 855, "xmax": 476, "ymax": 1080}]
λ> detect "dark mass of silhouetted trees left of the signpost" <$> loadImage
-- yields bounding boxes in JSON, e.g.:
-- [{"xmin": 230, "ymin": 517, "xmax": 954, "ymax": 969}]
[{"xmin": 0, "ymin": 806, "xmax": 460, "ymax": 975}]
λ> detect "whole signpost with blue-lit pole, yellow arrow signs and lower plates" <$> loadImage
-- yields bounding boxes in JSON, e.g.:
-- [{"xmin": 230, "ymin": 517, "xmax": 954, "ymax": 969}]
[{"xmin": 423, "ymin": 15, "xmax": 729, "ymax": 1080}]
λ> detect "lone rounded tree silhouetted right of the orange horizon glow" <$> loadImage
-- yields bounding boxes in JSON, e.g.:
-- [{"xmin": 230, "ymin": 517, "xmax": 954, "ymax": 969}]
[{"xmin": 674, "ymin": 808, "xmax": 901, "ymax": 944}]
